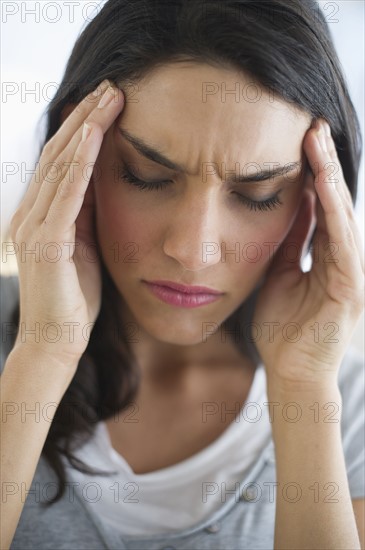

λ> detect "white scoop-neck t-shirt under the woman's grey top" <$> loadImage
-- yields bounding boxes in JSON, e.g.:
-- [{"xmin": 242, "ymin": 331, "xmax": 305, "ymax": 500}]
[{"xmin": 65, "ymin": 364, "xmax": 271, "ymax": 535}]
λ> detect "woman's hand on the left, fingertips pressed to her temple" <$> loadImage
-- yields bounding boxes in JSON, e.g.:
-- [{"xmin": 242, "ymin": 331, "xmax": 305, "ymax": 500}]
[{"xmin": 10, "ymin": 81, "xmax": 124, "ymax": 370}]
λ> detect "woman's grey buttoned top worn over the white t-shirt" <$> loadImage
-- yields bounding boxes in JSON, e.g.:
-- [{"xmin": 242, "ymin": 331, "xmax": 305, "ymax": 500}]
[{"xmin": 0, "ymin": 277, "xmax": 365, "ymax": 550}]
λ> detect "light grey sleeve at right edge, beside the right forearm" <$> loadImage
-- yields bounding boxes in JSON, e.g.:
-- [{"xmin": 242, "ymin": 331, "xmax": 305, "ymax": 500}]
[{"xmin": 338, "ymin": 348, "xmax": 365, "ymax": 498}]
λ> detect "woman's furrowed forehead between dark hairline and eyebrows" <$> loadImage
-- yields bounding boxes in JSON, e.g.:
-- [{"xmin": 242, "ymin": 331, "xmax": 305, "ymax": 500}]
[{"xmin": 121, "ymin": 62, "xmax": 311, "ymax": 167}]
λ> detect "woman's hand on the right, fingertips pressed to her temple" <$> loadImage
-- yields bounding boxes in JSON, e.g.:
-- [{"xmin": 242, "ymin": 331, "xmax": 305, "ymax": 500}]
[{"xmin": 253, "ymin": 119, "xmax": 364, "ymax": 390}]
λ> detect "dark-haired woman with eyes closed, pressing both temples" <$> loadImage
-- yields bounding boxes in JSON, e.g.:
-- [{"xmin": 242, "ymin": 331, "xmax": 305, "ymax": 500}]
[{"xmin": 2, "ymin": 0, "xmax": 364, "ymax": 549}]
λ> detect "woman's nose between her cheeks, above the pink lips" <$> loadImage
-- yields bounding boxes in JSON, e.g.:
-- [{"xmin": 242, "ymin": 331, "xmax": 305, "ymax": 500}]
[{"xmin": 163, "ymin": 190, "xmax": 223, "ymax": 271}]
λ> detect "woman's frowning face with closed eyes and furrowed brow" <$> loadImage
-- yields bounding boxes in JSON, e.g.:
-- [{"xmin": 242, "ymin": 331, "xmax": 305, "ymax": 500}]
[{"xmin": 94, "ymin": 63, "xmax": 311, "ymax": 345}]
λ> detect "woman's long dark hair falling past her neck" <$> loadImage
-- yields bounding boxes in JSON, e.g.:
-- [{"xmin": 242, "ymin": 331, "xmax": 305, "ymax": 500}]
[{"xmin": 7, "ymin": 0, "xmax": 362, "ymax": 505}]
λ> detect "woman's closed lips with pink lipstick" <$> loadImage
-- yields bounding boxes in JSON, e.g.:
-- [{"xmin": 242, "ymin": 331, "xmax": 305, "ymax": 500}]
[{"xmin": 142, "ymin": 280, "xmax": 224, "ymax": 308}]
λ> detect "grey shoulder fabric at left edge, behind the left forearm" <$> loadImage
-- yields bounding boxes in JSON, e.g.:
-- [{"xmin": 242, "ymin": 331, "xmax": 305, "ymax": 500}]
[{"xmin": 0, "ymin": 275, "xmax": 19, "ymax": 372}]
